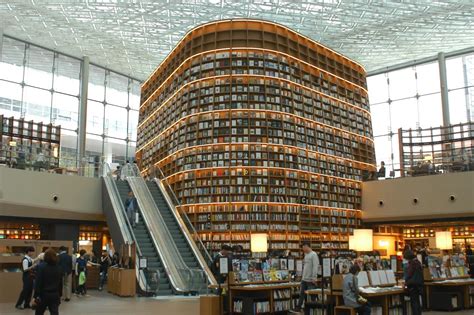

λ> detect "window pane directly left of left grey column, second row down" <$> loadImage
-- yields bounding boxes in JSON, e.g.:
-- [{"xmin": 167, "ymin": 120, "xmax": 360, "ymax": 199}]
[{"xmin": 52, "ymin": 93, "xmax": 79, "ymax": 130}]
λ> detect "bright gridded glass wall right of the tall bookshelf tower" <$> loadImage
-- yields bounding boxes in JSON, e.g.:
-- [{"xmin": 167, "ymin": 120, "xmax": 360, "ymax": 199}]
[{"xmin": 367, "ymin": 54, "xmax": 474, "ymax": 176}]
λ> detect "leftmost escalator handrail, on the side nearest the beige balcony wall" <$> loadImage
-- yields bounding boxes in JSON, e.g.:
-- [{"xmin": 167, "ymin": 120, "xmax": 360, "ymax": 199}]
[{"xmin": 101, "ymin": 162, "xmax": 148, "ymax": 292}]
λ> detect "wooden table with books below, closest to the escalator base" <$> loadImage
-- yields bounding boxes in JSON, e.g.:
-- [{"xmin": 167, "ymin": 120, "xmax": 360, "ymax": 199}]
[{"xmin": 229, "ymin": 282, "xmax": 300, "ymax": 314}]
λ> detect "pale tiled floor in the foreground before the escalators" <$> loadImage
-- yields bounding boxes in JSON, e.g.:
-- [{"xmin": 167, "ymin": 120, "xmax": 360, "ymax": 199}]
[{"xmin": 0, "ymin": 290, "xmax": 474, "ymax": 315}]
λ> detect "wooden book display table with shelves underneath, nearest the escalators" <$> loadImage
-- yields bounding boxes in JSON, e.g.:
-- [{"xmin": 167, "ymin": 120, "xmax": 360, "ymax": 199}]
[{"xmin": 229, "ymin": 282, "xmax": 300, "ymax": 314}]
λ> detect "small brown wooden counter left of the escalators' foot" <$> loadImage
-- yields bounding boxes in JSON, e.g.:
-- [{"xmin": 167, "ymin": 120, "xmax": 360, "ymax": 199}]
[{"xmin": 107, "ymin": 267, "xmax": 137, "ymax": 296}]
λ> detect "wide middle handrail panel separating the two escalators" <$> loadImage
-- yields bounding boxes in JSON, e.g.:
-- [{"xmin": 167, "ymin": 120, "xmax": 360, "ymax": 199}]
[{"xmin": 122, "ymin": 165, "xmax": 193, "ymax": 292}]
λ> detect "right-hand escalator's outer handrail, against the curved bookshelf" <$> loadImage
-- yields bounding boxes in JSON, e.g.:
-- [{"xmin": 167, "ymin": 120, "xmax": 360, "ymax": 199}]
[{"xmin": 155, "ymin": 178, "xmax": 217, "ymax": 285}]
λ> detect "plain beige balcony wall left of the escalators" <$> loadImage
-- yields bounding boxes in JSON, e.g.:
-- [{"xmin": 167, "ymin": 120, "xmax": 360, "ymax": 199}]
[{"xmin": 0, "ymin": 167, "xmax": 104, "ymax": 221}]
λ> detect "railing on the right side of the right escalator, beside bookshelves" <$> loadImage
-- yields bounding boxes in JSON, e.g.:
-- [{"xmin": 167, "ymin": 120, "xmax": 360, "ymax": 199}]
[{"xmin": 155, "ymin": 167, "xmax": 217, "ymax": 285}]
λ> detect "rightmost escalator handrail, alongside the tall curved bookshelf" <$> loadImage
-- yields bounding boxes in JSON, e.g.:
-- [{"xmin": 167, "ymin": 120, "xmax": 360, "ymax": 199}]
[{"xmin": 155, "ymin": 178, "xmax": 217, "ymax": 285}]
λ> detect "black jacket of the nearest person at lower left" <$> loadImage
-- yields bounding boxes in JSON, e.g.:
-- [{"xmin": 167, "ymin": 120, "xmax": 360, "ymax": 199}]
[{"xmin": 35, "ymin": 263, "xmax": 62, "ymax": 298}]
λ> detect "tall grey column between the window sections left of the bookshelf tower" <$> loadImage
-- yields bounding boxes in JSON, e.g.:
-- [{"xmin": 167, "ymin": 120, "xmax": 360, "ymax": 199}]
[{"xmin": 77, "ymin": 56, "xmax": 89, "ymax": 175}]
